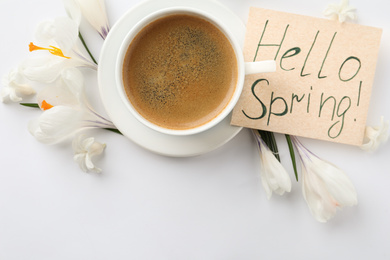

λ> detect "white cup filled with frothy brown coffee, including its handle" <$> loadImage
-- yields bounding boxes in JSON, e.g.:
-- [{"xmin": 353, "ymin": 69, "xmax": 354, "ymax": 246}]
[{"xmin": 116, "ymin": 7, "xmax": 275, "ymax": 135}]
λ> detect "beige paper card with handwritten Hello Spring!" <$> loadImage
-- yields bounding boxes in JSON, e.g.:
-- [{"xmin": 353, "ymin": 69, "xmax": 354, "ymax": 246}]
[{"xmin": 231, "ymin": 8, "xmax": 382, "ymax": 145}]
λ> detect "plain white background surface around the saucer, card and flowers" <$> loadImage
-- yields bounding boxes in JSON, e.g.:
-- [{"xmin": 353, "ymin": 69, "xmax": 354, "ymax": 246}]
[{"xmin": 0, "ymin": 0, "xmax": 390, "ymax": 260}]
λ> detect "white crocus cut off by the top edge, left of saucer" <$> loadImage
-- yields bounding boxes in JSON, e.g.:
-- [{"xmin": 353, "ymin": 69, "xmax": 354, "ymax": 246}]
[{"xmin": 64, "ymin": 0, "xmax": 110, "ymax": 39}]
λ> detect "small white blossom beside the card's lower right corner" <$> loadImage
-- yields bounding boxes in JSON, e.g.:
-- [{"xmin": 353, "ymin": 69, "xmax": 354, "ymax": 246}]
[{"xmin": 361, "ymin": 116, "xmax": 389, "ymax": 152}]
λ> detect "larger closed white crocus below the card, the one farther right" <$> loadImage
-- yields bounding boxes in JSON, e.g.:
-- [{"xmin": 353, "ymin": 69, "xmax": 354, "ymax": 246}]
[{"xmin": 291, "ymin": 136, "xmax": 357, "ymax": 222}]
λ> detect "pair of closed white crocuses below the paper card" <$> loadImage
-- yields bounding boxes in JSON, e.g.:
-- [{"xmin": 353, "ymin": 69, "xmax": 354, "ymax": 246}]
[{"xmin": 252, "ymin": 130, "xmax": 357, "ymax": 222}]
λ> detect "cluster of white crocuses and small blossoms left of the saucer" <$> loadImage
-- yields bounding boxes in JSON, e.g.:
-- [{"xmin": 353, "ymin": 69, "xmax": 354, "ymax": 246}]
[{"xmin": 0, "ymin": 0, "xmax": 115, "ymax": 172}]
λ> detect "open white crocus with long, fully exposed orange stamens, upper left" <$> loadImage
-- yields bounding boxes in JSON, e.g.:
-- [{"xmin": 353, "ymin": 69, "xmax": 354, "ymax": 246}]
[{"xmin": 21, "ymin": 17, "xmax": 97, "ymax": 83}]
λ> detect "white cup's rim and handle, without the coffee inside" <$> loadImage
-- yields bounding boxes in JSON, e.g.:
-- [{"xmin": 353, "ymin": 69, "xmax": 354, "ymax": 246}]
[{"xmin": 115, "ymin": 7, "xmax": 276, "ymax": 135}]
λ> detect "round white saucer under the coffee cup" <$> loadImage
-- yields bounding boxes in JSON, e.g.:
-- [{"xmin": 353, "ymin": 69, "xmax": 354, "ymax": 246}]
[{"xmin": 98, "ymin": 0, "xmax": 245, "ymax": 157}]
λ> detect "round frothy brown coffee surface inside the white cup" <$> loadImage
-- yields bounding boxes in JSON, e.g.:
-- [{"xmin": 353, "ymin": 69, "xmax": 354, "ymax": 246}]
[{"xmin": 123, "ymin": 14, "xmax": 237, "ymax": 130}]
